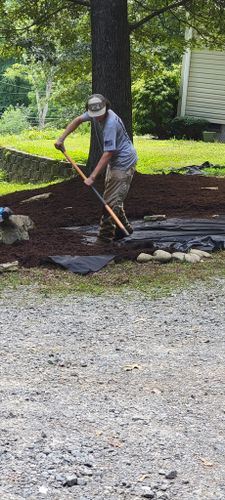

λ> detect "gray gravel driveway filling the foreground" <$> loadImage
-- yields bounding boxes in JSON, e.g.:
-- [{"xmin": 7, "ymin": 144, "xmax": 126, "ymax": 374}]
[{"xmin": 0, "ymin": 279, "xmax": 225, "ymax": 500}]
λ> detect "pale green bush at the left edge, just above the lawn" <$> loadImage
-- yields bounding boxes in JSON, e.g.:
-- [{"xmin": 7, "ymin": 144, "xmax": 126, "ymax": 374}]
[{"xmin": 0, "ymin": 106, "xmax": 29, "ymax": 135}]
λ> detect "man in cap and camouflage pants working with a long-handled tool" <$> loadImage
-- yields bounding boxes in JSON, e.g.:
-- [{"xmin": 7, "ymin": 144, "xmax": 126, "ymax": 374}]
[{"xmin": 55, "ymin": 94, "xmax": 137, "ymax": 243}]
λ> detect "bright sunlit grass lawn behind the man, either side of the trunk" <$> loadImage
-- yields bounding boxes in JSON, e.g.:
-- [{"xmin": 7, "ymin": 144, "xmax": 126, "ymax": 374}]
[{"xmin": 0, "ymin": 130, "xmax": 225, "ymax": 175}]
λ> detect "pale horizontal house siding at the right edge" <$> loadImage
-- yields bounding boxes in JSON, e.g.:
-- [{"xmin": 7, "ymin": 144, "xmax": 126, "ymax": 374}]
[{"xmin": 179, "ymin": 50, "xmax": 225, "ymax": 124}]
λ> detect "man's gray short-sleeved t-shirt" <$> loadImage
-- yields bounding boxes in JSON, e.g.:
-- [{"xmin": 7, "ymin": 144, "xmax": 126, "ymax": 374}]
[{"xmin": 81, "ymin": 109, "xmax": 137, "ymax": 170}]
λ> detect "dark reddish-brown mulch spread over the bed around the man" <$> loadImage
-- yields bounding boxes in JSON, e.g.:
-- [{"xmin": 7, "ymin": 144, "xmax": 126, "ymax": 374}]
[{"xmin": 0, "ymin": 173, "xmax": 225, "ymax": 267}]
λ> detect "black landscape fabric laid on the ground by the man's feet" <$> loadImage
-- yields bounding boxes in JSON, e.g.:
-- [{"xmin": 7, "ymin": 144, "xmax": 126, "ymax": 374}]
[{"xmin": 43, "ymin": 219, "xmax": 225, "ymax": 275}]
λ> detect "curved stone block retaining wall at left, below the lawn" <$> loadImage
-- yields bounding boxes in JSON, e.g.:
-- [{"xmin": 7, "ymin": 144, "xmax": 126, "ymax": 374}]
[{"xmin": 0, "ymin": 147, "xmax": 76, "ymax": 183}]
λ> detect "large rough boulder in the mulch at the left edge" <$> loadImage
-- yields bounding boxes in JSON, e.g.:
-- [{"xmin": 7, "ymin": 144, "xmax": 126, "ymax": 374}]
[{"xmin": 0, "ymin": 215, "xmax": 34, "ymax": 245}]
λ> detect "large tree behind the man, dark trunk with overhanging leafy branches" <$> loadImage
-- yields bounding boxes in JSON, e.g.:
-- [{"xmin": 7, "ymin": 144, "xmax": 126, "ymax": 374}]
[{"xmin": 0, "ymin": 0, "xmax": 225, "ymax": 163}]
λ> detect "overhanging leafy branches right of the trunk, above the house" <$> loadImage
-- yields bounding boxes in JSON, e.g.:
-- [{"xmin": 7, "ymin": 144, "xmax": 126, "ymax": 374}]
[{"xmin": 128, "ymin": 0, "xmax": 225, "ymax": 51}]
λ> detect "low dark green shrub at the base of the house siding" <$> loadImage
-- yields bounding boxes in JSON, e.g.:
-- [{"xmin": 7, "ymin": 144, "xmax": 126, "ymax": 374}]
[{"xmin": 170, "ymin": 116, "xmax": 209, "ymax": 140}]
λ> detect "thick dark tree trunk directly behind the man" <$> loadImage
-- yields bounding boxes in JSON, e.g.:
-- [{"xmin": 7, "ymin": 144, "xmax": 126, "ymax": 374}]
[{"xmin": 88, "ymin": 0, "xmax": 132, "ymax": 170}]
